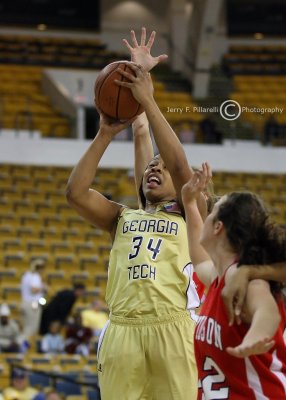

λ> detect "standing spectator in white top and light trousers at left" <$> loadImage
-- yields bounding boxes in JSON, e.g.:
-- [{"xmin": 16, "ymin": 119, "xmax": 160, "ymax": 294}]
[{"xmin": 21, "ymin": 258, "xmax": 47, "ymax": 340}]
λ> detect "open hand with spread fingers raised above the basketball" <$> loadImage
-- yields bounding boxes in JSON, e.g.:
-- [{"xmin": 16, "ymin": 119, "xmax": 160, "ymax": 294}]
[{"xmin": 123, "ymin": 27, "xmax": 168, "ymax": 71}]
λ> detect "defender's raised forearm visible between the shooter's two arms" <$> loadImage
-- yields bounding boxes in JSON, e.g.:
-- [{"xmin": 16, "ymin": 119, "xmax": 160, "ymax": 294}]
[{"xmin": 132, "ymin": 113, "xmax": 154, "ymax": 208}]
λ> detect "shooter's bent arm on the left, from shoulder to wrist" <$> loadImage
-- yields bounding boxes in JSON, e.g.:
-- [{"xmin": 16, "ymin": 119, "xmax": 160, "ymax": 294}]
[{"xmin": 66, "ymin": 115, "xmax": 130, "ymax": 234}]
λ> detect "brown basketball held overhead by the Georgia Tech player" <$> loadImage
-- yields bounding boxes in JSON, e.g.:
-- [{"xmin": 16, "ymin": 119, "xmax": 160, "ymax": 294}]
[{"xmin": 94, "ymin": 61, "xmax": 144, "ymax": 121}]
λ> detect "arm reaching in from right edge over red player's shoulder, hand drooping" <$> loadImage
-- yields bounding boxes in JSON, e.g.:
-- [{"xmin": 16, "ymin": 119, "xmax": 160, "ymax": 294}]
[{"xmin": 222, "ymin": 262, "xmax": 286, "ymax": 325}]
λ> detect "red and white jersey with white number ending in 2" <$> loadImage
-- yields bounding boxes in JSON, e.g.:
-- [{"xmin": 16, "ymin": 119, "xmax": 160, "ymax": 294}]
[{"xmin": 195, "ymin": 277, "xmax": 286, "ymax": 400}]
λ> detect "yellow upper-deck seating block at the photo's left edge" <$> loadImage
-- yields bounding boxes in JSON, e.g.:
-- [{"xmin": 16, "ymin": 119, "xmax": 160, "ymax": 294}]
[{"xmin": 0, "ymin": 64, "xmax": 70, "ymax": 137}]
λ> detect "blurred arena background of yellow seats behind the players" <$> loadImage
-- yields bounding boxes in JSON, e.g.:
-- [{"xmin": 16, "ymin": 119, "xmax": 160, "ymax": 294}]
[{"xmin": 0, "ymin": 0, "xmax": 286, "ymax": 400}]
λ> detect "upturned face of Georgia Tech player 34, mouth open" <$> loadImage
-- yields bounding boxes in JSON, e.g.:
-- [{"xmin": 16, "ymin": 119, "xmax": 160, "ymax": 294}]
[{"xmin": 143, "ymin": 155, "xmax": 176, "ymax": 203}]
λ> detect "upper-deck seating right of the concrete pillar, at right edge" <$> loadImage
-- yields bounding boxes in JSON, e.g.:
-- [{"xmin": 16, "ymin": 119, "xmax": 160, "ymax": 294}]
[{"xmin": 222, "ymin": 44, "xmax": 286, "ymax": 141}]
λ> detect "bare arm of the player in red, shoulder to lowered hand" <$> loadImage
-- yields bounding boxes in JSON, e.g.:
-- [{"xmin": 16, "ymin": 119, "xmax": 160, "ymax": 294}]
[{"xmin": 226, "ymin": 280, "xmax": 280, "ymax": 357}]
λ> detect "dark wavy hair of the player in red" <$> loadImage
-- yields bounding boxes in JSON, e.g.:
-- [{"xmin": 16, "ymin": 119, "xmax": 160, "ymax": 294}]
[{"xmin": 216, "ymin": 192, "xmax": 286, "ymax": 292}]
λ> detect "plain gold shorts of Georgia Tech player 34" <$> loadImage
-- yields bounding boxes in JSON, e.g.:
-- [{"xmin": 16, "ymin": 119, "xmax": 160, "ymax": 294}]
[{"xmin": 98, "ymin": 311, "xmax": 197, "ymax": 400}]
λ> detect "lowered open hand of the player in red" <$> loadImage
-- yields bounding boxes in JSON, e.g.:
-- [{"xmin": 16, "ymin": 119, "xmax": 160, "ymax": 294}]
[{"xmin": 226, "ymin": 337, "xmax": 275, "ymax": 358}]
